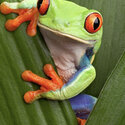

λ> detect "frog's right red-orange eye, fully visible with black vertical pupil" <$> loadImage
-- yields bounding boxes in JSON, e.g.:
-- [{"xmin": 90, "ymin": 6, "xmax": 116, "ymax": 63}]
[{"xmin": 85, "ymin": 13, "xmax": 103, "ymax": 33}]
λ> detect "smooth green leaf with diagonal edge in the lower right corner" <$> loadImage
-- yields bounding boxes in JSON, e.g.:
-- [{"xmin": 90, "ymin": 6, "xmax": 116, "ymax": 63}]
[{"xmin": 86, "ymin": 52, "xmax": 125, "ymax": 125}]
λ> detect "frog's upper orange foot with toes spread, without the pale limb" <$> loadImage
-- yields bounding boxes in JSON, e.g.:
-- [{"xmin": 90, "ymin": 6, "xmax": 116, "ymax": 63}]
[{"xmin": 0, "ymin": 3, "xmax": 39, "ymax": 36}]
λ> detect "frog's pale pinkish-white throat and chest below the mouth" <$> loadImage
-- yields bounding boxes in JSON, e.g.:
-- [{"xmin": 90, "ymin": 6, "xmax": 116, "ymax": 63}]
[{"xmin": 40, "ymin": 24, "xmax": 92, "ymax": 82}]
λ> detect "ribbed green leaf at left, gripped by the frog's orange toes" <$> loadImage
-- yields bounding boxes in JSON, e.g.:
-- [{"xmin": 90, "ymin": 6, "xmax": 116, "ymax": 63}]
[{"xmin": 0, "ymin": 0, "xmax": 77, "ymax": 125}]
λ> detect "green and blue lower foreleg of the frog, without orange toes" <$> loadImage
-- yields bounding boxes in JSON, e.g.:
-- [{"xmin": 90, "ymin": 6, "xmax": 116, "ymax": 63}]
[{"xmin": 34, "ymin": 64, "xmax": 96, "ymax": 100}]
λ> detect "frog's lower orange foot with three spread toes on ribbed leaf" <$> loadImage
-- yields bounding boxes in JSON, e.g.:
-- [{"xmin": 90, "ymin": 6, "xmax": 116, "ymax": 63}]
[{"xmin": 22, "ymin": 64, "xmax": 63, "ymax": 103}]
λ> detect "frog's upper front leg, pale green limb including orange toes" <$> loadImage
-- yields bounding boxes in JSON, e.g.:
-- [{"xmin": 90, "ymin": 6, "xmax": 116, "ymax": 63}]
[{"xmin": 0, "ymin": 0, "xmax": 39, "ymax": 36}]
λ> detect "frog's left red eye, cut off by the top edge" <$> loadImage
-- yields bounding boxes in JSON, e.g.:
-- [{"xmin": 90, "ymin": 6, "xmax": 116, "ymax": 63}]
[{"xmin": 37, "ymin": 0, "xmax": 50, "ymax": 15}]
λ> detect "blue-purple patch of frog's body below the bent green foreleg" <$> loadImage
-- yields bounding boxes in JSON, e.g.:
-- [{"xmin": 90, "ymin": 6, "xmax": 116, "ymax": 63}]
[{"xmin": 69, "ymin": 94, "xmax": 97, "ymax": 119}]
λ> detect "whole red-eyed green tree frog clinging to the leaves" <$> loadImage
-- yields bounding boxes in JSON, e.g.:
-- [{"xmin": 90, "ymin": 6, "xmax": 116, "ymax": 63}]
[{"xmin": 0, "ymin": 0, "xmax": 103, "ymax": 125}]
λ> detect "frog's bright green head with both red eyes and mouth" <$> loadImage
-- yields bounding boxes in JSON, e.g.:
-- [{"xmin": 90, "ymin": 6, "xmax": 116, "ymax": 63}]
[{"xmin": 37, "ymin": 0, "xmax": 103, "ymax": 48}]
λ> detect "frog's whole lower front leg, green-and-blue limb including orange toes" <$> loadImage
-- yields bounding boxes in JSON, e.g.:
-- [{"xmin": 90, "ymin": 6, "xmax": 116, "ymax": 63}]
[{"xmin": 22, "ymin": 64, "xmax": 96, "ymax": 103}]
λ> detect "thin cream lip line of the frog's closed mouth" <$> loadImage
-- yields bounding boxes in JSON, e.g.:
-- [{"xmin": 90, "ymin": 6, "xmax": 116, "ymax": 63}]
[{"xmin": 38, "ymin": 22, "xmax": 96, "ymax": 45}]
